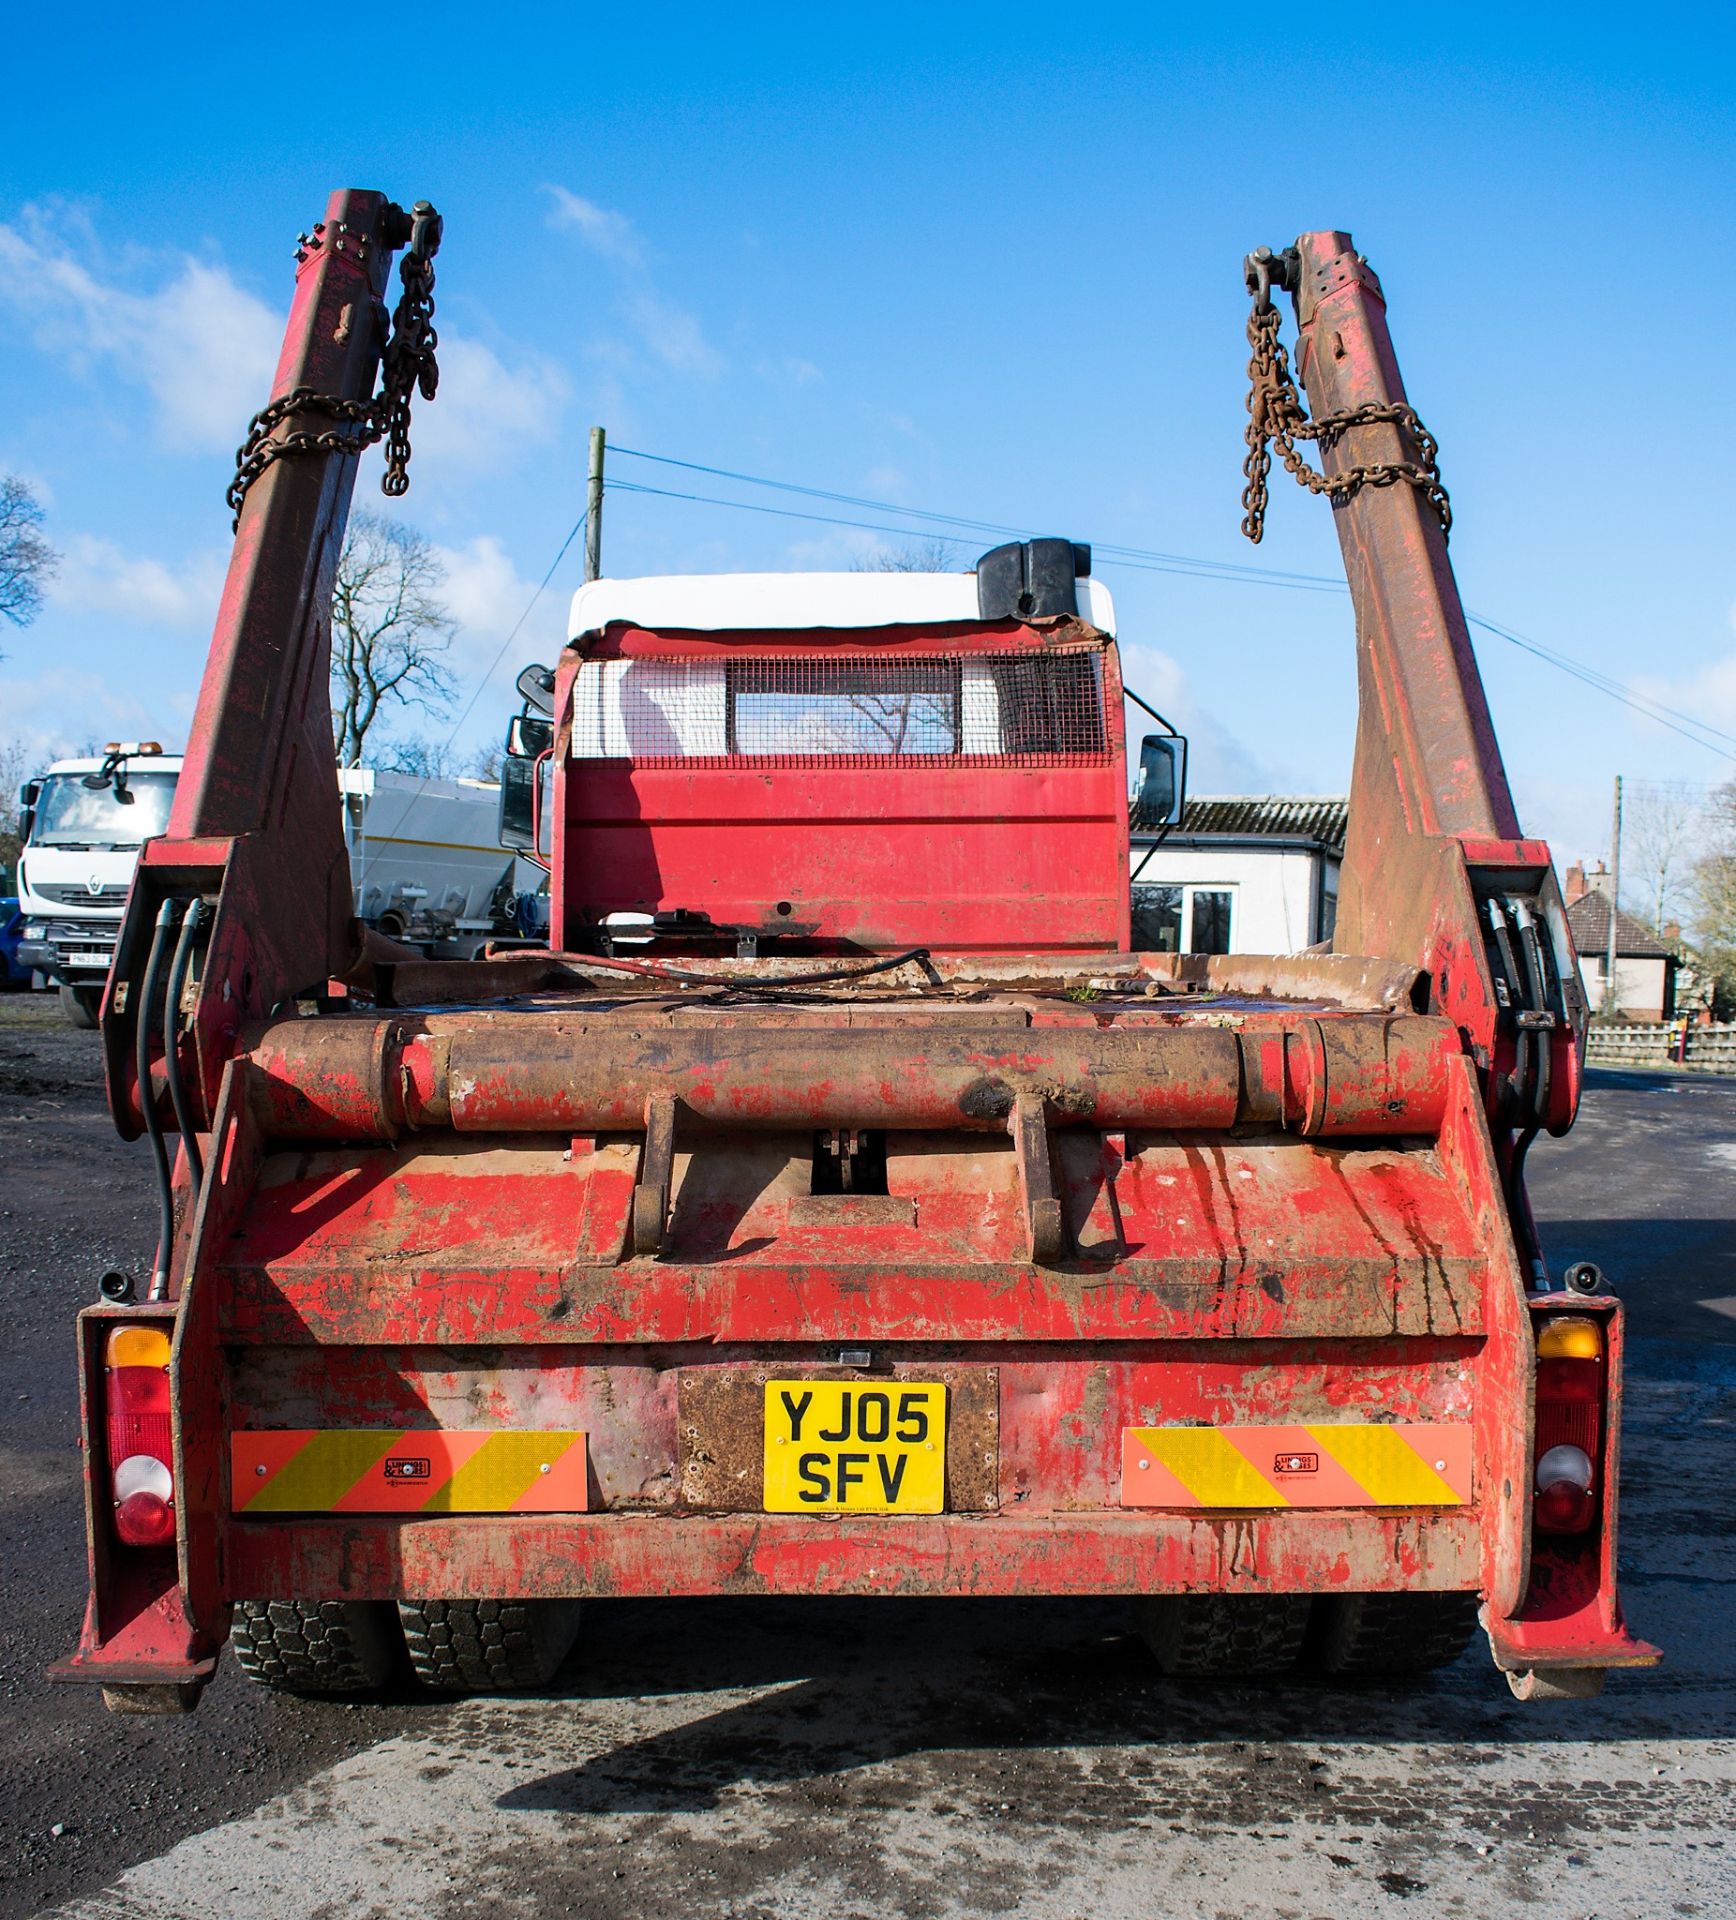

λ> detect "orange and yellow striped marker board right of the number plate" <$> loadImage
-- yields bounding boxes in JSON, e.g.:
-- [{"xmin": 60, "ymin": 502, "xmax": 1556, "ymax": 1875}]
[{"xmin": 1121, "ymin": 1421, "xmax": 1471, "ymax": 1507}]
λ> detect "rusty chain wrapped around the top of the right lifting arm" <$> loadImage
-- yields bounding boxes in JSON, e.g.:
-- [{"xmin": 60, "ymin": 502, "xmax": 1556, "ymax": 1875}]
[{"xmin": 1242, "ymin": 295, "xmax": 1452, "ymax": 545}]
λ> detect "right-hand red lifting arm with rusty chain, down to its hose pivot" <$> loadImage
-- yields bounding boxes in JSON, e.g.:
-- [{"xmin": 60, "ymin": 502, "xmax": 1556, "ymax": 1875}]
[{"xmin": 1248, "ymin": 232, "xmax": 1584, "ymax": 1144}]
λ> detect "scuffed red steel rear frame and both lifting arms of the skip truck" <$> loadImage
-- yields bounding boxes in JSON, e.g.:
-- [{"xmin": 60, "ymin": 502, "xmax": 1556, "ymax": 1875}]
[{"xmin": 58, "ymin": 192, "xmax": 1657, "ymax": 1697}]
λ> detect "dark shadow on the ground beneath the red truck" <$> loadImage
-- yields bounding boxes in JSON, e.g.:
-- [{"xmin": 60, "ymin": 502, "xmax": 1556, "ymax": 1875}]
[{"xmin": 497, "ymin": 1592, "xmax": 1736, "ymax": 1818}]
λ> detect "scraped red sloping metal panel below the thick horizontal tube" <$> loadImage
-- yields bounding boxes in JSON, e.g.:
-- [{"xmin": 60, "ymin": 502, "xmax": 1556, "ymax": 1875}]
[{"xmin": 221, "ymin": 1133, "xmax": 1486, "ymax": 1344}]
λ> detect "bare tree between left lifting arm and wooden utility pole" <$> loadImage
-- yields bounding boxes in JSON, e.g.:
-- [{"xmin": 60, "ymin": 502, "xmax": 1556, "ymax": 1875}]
[{"xmin": 332, "ymin": 513, "xmax": 457, "ymax": 766}]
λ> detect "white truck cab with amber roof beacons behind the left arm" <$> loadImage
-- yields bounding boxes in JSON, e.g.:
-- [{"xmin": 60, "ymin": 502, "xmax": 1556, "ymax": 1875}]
[{"xmin": 17, "ymin": 739, "xmax": 181, "ymax": 1027}]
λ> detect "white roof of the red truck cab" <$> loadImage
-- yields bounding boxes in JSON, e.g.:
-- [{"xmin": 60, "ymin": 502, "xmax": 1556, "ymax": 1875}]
[{"xmin": 568, "ymin": 572, "xmax": 1116, "ymax": 639}]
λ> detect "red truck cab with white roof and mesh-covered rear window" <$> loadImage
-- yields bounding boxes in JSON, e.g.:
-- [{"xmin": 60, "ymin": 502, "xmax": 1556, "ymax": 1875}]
[{"xmin": 545, "ymin": 540, "xmax": 1129, "ymax": 956}]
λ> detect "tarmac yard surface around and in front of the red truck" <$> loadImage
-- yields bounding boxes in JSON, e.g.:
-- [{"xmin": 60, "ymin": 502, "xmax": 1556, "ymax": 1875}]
[{"xmin": 0, "ymin": 995, "xmax": 1736, "ymax": 1920}]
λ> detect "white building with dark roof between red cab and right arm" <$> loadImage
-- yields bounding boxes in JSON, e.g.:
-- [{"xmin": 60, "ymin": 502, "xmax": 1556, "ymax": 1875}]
[{"xmin": 1131, "ymin": 793, "xmax": 1348, "ymax": 954}]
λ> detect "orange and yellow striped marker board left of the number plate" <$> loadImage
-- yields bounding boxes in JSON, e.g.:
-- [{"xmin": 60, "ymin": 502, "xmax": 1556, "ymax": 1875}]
[{"xmin": 229, "ymin": 1427, "xmax": 590, "ymax": 1517}]
